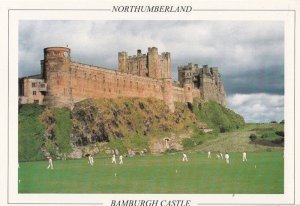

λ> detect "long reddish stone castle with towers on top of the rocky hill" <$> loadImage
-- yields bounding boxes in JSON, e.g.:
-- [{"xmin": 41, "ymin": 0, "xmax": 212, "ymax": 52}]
[{"xmin": 19, "ymin": 47, "xmax": 226, "ymax": 111}]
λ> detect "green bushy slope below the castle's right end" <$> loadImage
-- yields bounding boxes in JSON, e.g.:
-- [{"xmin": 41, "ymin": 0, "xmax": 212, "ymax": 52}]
[{"xmin": 193, "ymin": 99, "xmax": 245, "ymax": 132}]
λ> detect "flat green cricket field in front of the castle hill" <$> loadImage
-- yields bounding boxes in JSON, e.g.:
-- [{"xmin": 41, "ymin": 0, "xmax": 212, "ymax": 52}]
[{"xmin": 19, "ymin": 151, "xmax": 284, "ymax": 194}]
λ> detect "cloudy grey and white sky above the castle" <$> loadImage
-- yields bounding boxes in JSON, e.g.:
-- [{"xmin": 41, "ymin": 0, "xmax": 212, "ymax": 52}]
[{"xmin": 19, "ymin": 21, "xmax": 284, "ymax": 122}]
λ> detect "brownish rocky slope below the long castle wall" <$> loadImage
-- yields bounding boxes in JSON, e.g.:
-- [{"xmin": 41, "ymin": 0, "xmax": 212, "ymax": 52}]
[{"xmin": 71, "ymin": 98, "xmax": 198, "ymax": 147}]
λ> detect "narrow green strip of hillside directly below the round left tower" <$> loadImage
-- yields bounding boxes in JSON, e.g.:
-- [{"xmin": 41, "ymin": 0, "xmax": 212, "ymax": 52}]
[{"xmin": 54, "ymin": 108, "xmax": 72, "ymax": 153}]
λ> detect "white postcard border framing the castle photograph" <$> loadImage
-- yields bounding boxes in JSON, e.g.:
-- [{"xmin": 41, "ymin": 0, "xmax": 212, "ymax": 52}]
[{"xmin": 1, "ymin": 1, "xmax": 295, "ymax": 205}]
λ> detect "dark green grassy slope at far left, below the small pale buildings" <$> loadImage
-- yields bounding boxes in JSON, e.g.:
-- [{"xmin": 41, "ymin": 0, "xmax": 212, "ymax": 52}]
[{"xmin": 18, "ymin": 104, "xmax": 45, "ymax": 161}]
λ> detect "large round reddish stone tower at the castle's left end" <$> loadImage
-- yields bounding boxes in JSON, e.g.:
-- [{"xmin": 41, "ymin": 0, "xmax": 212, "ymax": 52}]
[{"xmin": 42, "ymin": 47, "xmax": 72, "ymax": 107}]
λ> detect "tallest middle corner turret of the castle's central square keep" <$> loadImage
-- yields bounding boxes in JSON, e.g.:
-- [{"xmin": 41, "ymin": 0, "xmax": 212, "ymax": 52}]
[{"xmin": 147, "ymin": 47, "xmax": 161, "ymax": 79}]
